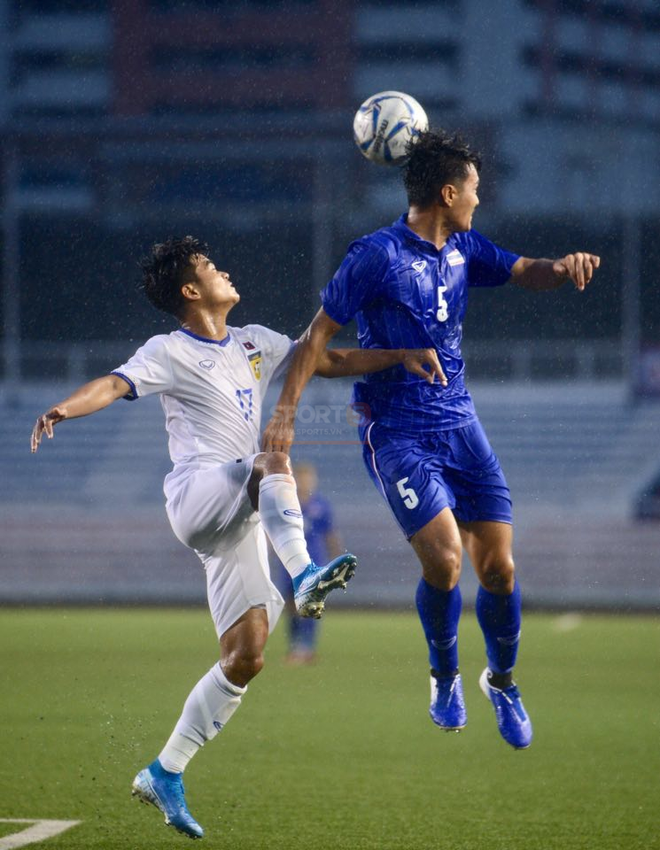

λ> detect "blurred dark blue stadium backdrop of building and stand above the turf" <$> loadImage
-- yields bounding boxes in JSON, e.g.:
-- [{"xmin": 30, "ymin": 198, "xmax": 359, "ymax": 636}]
[{"xmin": 0, "ymin": 0, "xmax": 660, "ymax": 610}]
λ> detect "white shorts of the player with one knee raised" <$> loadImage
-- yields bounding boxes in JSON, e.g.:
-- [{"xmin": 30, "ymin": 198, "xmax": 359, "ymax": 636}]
[{"xmin": 165, "ymin": 455, "xmax": 284, "ymax": 637}]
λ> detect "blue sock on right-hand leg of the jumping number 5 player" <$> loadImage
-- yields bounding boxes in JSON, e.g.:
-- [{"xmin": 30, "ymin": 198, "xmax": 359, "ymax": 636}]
[{"xmin": 476, "ymin": 582, "xmax": 521, "ymax": 673}]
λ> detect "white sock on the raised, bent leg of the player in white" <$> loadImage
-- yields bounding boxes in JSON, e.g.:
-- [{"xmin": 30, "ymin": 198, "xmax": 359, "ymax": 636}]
[{"xmin": 259, "ymin": 473, "xmax": 312, "ymax": 578}]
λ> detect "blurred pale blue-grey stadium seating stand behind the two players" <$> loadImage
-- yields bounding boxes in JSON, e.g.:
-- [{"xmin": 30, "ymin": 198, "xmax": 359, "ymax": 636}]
[{"xmin": 0, "ymin": 382, "xmax": 660, "ymax": 608}]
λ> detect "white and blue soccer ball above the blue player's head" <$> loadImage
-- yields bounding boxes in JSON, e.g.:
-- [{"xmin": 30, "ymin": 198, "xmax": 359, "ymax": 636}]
[{"xmin": 353, "ymin": 91, "xmax": 429, "ymax": 165}]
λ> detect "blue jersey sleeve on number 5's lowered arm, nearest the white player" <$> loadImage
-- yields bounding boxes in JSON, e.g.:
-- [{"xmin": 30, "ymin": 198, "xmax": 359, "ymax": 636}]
[{"xmin": 321, "ymin": 241, "xmax": 389, "ymax": 325}]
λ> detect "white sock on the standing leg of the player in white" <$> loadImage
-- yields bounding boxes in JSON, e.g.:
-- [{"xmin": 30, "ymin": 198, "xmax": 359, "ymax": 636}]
[{"xmin": 158, "ymin": 662, "xmax": 247, "ymax": 773}]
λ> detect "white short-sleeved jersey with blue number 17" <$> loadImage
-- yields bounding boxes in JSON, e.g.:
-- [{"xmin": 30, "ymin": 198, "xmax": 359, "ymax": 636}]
[{"xmin": 113, "ymin": 325, "xmax": 295, "ymax": 471}]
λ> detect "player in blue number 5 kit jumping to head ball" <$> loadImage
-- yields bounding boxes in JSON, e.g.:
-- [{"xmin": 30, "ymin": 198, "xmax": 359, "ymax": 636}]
[{"xmin": 262, "ymin": 130, "xmax": 600, "ymax": 749}]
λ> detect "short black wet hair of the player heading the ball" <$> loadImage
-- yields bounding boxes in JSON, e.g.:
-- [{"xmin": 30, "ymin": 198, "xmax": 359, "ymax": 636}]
[{"xmin": 403, "ymin": 130, "xmax": 481, "ymax": 207}]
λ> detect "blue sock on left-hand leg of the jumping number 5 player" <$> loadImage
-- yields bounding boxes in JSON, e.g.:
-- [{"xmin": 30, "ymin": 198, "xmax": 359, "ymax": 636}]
[{"xmin": 415, "ymin": 578, "xmax": 462, "ymax": 676}]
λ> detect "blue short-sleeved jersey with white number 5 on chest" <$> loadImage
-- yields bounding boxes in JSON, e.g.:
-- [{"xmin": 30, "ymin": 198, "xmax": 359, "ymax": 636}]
[{"xmin": 321, "ymin": 215, "xmax": 519, "ymax": 430}]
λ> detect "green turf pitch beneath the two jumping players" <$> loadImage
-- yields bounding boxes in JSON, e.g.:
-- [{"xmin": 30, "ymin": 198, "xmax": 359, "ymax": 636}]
[{"xmin": 0, "ymin": 610, "xmax": 660, "ymax": 850}]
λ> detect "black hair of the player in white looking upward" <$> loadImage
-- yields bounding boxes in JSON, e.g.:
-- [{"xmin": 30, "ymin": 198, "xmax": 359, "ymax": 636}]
[{"xmin": 140, "ymin": 236, "xmax": 209, "ymax": 318}]
